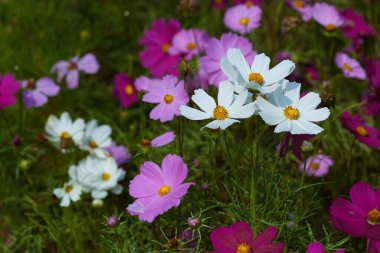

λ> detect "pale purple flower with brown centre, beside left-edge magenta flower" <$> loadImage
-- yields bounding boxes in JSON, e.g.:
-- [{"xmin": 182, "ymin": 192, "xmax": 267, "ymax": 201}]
[{"xmin": 21, "ymin": 77, "xmax": 60, "ymax": 108}]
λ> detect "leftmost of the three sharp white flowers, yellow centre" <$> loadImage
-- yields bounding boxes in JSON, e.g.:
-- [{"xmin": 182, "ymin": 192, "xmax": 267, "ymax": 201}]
[{"xmin": 179, "ymin": 81, "xmax": 255, "ymax": 130}]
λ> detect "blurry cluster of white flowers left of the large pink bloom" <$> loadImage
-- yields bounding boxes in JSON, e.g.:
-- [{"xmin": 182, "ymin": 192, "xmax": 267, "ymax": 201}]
[{"xmin": 45, "ymin": 112, "xmax": 125, "ymax": 207}]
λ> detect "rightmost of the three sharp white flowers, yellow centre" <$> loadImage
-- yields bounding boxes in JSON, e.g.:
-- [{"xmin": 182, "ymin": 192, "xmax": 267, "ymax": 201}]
[{"xmin": 257, "ymin": 83, "xmax": 330, "ymax": 134}]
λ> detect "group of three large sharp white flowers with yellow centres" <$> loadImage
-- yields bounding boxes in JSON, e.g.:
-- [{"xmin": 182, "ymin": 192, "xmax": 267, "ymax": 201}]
[{"xmin": 180, "ymin": 48, "xmax": 330, "ymax": 134}]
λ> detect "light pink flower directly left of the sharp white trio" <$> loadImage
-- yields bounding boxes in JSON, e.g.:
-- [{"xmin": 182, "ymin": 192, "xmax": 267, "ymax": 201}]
[{"xmin": 143, "ymin": 75, "xmax": 189, "ymax": 122}]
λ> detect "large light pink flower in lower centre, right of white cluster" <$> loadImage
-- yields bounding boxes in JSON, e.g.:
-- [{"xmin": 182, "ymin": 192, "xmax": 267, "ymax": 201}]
[{"xmin": 128, "ymin": 154, "xmax": 194, "ymax": 222}]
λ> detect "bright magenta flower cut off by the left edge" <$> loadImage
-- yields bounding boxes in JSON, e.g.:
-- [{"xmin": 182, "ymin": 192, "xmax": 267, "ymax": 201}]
[{"xmin": 0, "ymin": 74, "xmax": 21, "ymax": 110}]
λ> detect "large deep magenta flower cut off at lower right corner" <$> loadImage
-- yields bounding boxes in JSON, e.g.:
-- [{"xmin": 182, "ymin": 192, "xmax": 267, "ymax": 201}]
[{"xmin": 329, "ymin": 182, "xmax": 380, "ymax": 240}]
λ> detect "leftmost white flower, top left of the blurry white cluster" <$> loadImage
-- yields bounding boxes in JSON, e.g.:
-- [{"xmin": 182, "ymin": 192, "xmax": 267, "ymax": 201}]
[{"xmin": 45, "ymin": 112, "xmax": 85, "ymax": 150}]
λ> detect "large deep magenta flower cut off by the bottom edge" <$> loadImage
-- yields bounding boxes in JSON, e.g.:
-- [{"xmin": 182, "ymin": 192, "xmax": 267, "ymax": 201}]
[{"xmin": 210, "ymin": 221, "xmax": 284, "ymax": 253}]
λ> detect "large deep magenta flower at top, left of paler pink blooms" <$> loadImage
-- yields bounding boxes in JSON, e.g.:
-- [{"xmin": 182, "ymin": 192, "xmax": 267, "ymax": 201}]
[{"xmin": 139, "ymin": 19, "xmax": 181, "ymax": 78}]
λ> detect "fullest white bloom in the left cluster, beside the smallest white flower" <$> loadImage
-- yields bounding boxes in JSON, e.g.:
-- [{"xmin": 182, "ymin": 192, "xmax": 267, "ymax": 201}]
[{"xmin": 69, "ymin": 156, "xmax": 125, "ymax": 199}]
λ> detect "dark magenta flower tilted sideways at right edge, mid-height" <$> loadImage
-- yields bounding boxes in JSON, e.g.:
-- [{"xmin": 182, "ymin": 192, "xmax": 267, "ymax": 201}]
[{"xmin": 340, "ymin": 112, "xmax": 380, "ymax": 148}]
